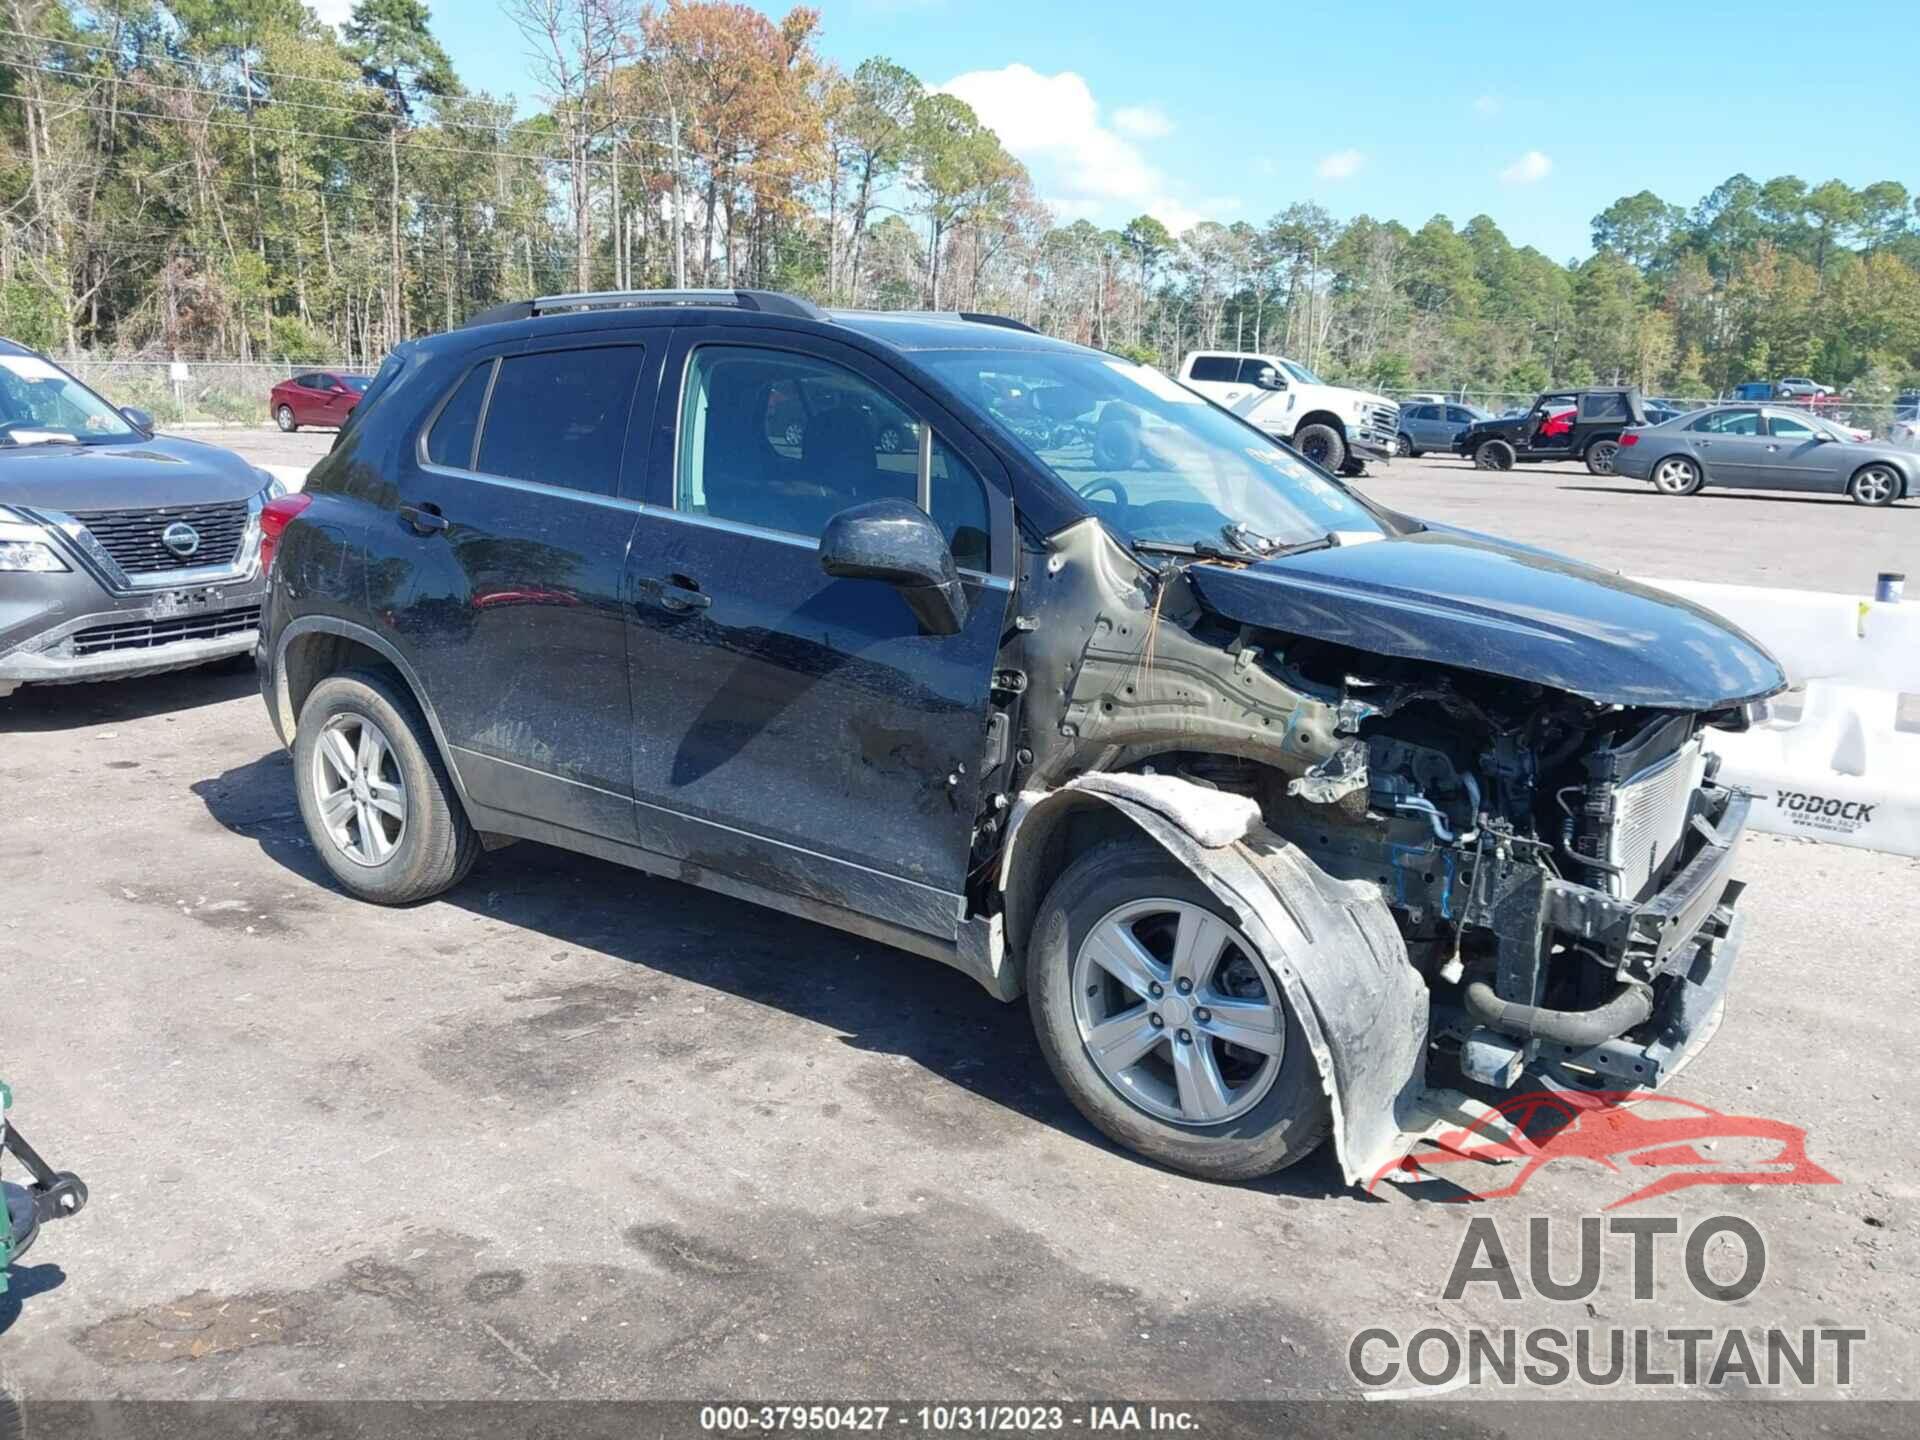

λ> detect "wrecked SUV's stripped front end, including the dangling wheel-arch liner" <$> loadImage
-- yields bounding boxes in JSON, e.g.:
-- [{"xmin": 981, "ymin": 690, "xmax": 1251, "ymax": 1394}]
[{"xmin": 1000, "ymin": 524, "xmax": 1776, "ymax": 1183}]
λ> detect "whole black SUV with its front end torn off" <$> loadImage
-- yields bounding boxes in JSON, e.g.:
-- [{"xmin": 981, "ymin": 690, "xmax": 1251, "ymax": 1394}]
[{"xmin": 259, "ymin": 292, "xmax": 1782, "ymax": 1183}]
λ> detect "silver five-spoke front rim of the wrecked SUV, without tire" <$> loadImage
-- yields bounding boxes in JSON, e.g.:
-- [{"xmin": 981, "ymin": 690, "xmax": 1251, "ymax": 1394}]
[{"xmin": 1073, "ymin": 899, "xmax": 1286, "ymax": 1125}]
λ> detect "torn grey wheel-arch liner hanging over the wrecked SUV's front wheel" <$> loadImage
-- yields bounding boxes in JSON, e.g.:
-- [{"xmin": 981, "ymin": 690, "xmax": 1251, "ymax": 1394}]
[{"xmin": 1000, "ymin": 774, "xmax": 1488, "ymax": 1185}]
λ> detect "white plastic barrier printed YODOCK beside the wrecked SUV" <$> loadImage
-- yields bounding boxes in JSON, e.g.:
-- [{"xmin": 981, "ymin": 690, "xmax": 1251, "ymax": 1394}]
[{"xmin": 1644, "ymin": 580, "xmax": 1920, "ymax": 854}]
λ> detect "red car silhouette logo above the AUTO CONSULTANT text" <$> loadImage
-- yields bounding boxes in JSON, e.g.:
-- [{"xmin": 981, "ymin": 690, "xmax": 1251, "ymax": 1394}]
[{"xmin": 1367, "ymin": 1091, "xmax": 1839, "ymax": 1210}]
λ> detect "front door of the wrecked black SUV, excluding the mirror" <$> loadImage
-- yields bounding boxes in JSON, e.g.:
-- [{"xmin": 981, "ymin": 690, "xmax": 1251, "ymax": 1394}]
[{"xmin": 628, "ymin": 326, "xmax": 1012, "ymax": 939}]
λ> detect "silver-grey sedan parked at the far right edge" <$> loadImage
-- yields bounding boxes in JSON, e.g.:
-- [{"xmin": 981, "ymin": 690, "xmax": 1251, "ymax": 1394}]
[{"xmin": 1613, "ymin": 405, "xmax": 1920, "ymax": 505}]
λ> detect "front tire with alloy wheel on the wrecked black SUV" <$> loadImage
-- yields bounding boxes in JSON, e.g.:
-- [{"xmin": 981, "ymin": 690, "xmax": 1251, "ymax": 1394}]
[{"xmin": 1027, "ymin": 837, "xmax": 1332, "ymax": 1181}]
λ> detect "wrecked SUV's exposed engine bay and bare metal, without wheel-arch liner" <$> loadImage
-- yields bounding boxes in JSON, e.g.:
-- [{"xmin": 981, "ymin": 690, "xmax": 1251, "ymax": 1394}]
[{"xmin": 981, "ymin": 534, "xmax": 1745, "ymax": 1173}]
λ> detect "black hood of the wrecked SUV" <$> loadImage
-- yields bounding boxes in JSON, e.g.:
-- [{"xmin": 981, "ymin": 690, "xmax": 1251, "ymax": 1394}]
[{"xmin": 1188, "ymin": 526, "xmax": 1786, "ymax": 710}]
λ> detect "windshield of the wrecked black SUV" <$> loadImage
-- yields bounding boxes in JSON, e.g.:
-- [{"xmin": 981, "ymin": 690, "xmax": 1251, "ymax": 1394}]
[{"xmin": 918, "ymin": 349, "xmax": 1384, "ymax": 549}]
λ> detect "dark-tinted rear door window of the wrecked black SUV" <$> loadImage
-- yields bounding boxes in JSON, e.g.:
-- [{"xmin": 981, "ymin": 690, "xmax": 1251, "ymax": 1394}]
[{"xmin": 474, "ymin": 346, "xmax": 643, "ymax": 495}]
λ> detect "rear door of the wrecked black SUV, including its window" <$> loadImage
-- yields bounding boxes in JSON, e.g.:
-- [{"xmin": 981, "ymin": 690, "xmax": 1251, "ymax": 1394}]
[{"xmin": 369, "ymin": 328, "xmax": 668, "ymax": 841}]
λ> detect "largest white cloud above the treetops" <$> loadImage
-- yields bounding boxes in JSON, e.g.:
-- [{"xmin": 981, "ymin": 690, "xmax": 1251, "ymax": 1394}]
[{"xmin": 935, "ymin": 63, "xmax": 1213, "ymax": 234}]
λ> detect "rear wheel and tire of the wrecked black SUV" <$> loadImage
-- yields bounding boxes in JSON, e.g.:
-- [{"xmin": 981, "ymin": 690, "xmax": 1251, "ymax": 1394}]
[{"xmin": 294, "ymin": 670, "xmax": 480, "ymax": 904}]
